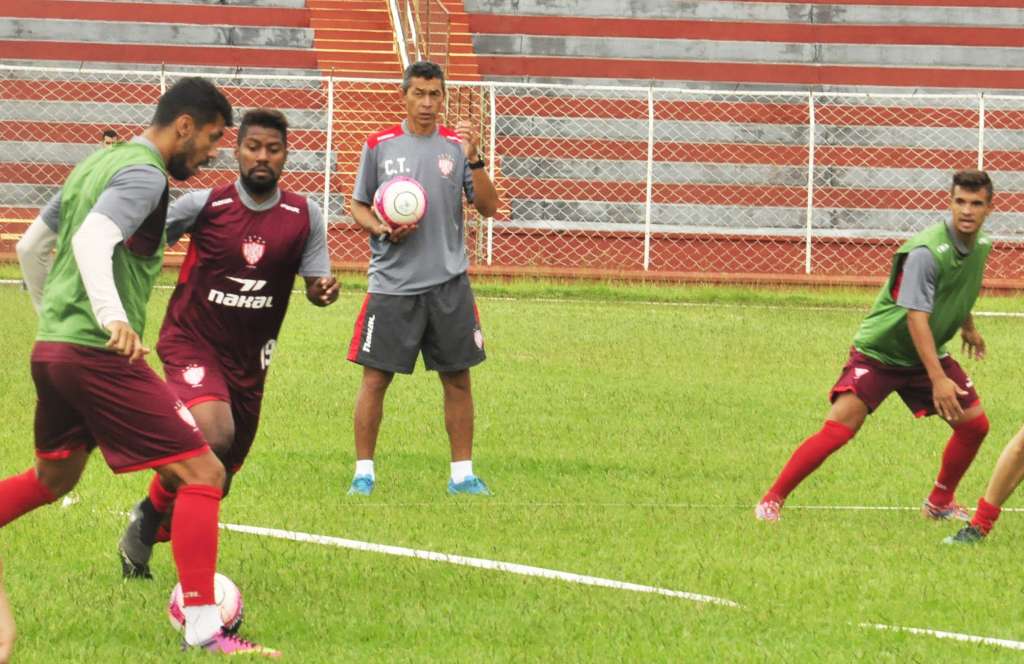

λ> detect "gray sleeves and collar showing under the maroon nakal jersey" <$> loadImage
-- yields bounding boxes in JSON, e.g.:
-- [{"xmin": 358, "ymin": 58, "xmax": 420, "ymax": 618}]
[{"xmin": 167, "ymin": 181, "xmax": 331, "ymax": 277}]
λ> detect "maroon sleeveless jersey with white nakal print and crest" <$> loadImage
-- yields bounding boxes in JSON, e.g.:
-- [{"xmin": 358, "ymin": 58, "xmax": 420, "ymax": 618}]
[{"xmin": 158, "ymin": 182, "xmax": 310, "ymax": 379}]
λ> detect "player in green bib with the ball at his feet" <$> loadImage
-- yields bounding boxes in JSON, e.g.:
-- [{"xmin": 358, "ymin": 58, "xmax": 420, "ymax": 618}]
[{"xmin": 12, "ymin": 78, "xmax": 280, "ymax": 656}]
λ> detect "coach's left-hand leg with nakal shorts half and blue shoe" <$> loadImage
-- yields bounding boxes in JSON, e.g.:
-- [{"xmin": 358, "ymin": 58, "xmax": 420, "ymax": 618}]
[{"xmin": 347, "ymin": 293, "xmax": 427, "ymax": 496}]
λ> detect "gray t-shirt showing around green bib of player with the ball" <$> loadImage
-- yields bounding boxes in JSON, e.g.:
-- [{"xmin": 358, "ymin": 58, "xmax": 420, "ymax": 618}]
[{"xmin": 39, "ymin": 136, "xmax": 167, "ymax": 238}]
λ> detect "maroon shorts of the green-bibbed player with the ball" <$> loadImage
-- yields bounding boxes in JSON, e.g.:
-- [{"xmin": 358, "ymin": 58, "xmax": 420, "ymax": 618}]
[{"xmin": 32, "ymin": 341, "xmax": 209, "ymax": 472}]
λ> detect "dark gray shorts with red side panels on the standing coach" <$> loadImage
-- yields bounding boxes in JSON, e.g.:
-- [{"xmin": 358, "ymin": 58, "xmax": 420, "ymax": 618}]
[{"xmin": 348, "ymin": 274, "xmax": 486, "ymax": 374}]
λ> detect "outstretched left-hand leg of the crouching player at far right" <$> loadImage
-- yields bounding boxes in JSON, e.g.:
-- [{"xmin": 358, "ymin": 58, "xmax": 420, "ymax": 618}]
[{"xmin": 755, "ymin": 350, "xmax": 898, "ymax": 522}]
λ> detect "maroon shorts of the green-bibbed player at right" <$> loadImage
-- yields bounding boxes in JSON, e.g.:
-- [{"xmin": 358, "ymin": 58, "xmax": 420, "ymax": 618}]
[{"xmin": 828, "ymin": 348, "xmax": 981, "ymax": 417}]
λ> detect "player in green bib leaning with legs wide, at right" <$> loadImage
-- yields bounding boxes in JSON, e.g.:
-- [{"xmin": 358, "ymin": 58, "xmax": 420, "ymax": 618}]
[{"xmin": 755, "ymin": 170, "xmax": 992, "ymax": 522}]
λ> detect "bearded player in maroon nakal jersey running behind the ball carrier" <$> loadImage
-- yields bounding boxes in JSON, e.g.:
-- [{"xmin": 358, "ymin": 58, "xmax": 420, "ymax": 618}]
[{"xmin": 119, "ymin": 109, "xmax": 338, "ymax": 578}]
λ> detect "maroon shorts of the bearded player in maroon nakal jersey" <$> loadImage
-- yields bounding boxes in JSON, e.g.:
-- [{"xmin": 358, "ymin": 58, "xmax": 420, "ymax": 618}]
[{"xmin": 157, "ymin": 337, "xmax": 266, "ymax": 472}]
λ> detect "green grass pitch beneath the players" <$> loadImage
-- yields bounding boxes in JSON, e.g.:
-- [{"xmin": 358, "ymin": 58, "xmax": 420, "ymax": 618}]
[{"xmin": 0, "ymin": 274, "xmax": 1024, "ymax": 664}]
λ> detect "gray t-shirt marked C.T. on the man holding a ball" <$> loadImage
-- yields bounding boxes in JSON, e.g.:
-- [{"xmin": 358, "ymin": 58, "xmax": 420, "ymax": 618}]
[{"xmin": 352, "ymin": 122, "xmax": 473, "ymax": 295}]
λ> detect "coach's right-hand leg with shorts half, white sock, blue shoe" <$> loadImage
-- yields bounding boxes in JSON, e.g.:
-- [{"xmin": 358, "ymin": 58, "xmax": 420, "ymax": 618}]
[{"xmin": 423, "ymin": 275, "xmax": 490, "ymax": 495}]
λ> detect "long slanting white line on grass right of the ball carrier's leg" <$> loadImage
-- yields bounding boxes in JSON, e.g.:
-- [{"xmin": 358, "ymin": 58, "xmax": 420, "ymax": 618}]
[{"xmin": 220, "ymin": 524, "xmax": 739, "ymax": 609}]
